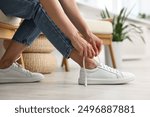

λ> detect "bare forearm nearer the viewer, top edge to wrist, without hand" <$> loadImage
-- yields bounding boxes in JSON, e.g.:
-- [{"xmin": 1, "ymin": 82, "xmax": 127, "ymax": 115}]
[{"xmin": 40, "ymin": 0, "xmax": 78, "ymax": 39}]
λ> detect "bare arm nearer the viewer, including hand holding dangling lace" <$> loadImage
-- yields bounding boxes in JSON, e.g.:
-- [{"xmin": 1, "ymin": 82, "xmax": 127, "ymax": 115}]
[{"xmin": 40, "ymin": 0, "xmax": 95, "ymax": 58}]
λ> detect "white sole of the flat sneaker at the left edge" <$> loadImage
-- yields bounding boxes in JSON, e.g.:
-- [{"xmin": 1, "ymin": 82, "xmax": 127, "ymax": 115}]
[{"xmin": 0, "ymin": 77, "xmax": 43, "ymax": 84}]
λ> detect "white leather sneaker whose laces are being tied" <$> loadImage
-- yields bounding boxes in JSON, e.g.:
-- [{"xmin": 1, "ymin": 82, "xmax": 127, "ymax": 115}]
[{"xmin": 78, "ymin": 64, "xmax": 135, "ymax": 85}]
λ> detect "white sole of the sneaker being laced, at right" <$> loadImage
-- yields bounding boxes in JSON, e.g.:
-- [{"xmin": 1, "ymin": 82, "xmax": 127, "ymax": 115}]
[{"xmin": 78, "ymin": 78, "xmax": 134, "ymax": 85}]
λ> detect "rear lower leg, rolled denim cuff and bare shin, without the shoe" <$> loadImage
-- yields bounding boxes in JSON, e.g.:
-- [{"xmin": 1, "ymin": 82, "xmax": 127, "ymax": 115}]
[{"xmin": 0, "ymin": 19, "xmax": 41, "ymax": 69}]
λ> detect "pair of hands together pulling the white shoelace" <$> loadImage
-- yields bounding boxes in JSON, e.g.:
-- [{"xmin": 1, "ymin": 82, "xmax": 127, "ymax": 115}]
[{"xmin": 71, "ymin": 33, "xmax": 102, "ymax": 58}]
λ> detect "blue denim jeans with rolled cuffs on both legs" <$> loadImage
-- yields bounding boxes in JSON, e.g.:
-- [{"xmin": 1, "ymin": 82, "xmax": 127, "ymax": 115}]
[{"xmin": 0, "ymin": 0, "xmax": 73, "ymax": 58}]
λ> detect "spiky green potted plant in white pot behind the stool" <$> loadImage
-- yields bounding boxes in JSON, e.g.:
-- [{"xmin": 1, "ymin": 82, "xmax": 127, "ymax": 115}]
[{"xmin": 101, "ymin": 8, "xmax": 145, "ymax": 68}]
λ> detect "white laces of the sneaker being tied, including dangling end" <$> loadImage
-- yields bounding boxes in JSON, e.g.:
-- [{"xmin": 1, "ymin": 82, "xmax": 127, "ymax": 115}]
[{"xmin": 83, "ymin": 56, "xmax": 120, "ymax": 86}]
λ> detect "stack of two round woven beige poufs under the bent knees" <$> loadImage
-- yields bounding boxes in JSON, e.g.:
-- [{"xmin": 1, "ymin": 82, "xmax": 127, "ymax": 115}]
[{"xmin": 23, "ymin": 34, "xmax": 56, "ymax": 73}]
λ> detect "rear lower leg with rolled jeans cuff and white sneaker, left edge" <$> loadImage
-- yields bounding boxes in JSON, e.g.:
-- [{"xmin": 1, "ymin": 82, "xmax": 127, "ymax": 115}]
[{"xmin": 0, "ymin": 19, "xmax": 44, "ymax": 83}]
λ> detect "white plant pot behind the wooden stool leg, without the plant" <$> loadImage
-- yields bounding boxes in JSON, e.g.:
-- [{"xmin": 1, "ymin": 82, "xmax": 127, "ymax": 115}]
[{"xmin": 105, "ymin": 42, "xmax": 122, "ymax": 69}]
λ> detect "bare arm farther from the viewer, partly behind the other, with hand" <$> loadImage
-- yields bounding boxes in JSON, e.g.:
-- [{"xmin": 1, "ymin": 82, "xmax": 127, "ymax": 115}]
[{"xmin": 59, "ymin": 0, "xmax": 102, "ymax": 54}]
